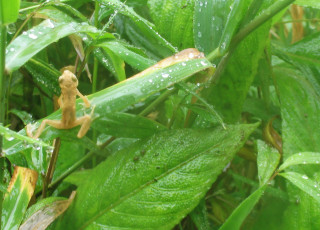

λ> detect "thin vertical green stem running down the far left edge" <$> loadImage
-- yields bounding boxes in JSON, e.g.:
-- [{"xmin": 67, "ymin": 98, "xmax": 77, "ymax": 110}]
[{"xmin": 0, "ymin": 23, "xmax": 7, "ymax": 228}]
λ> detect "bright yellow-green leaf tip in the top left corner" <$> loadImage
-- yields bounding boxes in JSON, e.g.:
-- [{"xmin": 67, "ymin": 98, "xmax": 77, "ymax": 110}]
[{"xmin": 0, "ymin": 0, "xmax": 20, "ymax": 25}]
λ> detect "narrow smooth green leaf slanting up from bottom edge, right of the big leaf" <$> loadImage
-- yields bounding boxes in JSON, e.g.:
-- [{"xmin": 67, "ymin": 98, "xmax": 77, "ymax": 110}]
[{"xmin": 219, "ymin": 185, "xmax": 267, "ymax": 230}]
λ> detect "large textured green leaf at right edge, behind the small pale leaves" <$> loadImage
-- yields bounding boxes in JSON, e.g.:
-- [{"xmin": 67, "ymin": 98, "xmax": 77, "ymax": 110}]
[{"xmin": 275, "ymin": 68, "xmax": 320, "ymax": 230}]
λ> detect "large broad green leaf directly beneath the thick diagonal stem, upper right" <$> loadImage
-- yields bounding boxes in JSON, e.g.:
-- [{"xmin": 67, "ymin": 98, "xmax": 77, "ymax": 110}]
[{"xmin": 204, "ymin": 0, "xmax": 273, "ymax": 122}]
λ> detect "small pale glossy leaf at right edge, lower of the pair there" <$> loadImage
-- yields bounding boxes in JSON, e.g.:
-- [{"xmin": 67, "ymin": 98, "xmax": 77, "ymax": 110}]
[{"xmin": 279, "ymin": 172, "xmax": 320, "ymax": 205}]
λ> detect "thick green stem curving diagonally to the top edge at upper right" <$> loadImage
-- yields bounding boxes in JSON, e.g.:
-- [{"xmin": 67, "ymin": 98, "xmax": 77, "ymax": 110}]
[{"xmin": 208, "ymin": 0, "xmax": 295, "ymax": 83}]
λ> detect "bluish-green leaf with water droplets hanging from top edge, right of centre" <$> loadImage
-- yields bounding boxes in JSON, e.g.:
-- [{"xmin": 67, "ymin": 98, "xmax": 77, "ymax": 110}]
[{"xmin": 193, "ymin": 0, "xmax": 233, "ymax": 55}]
